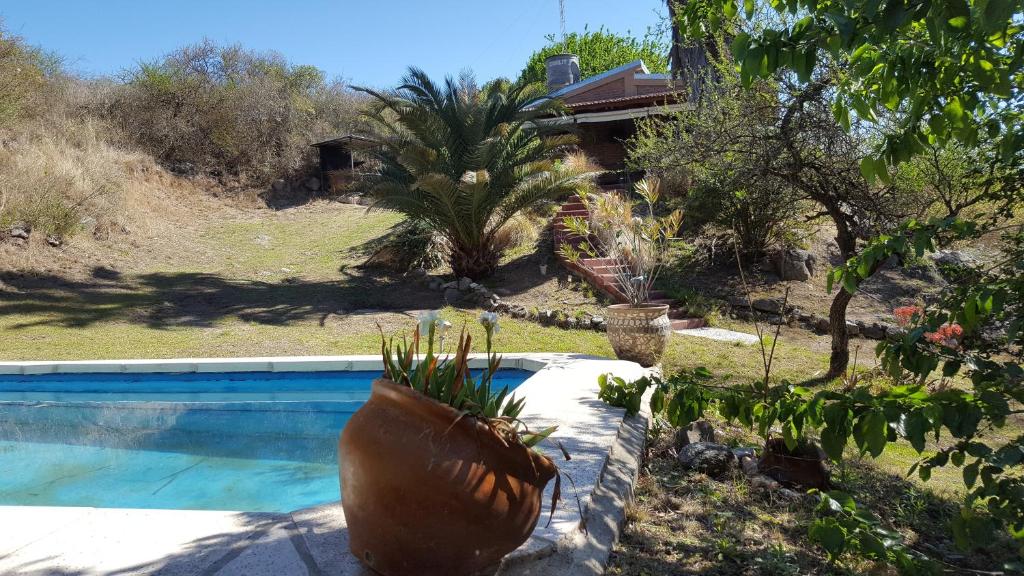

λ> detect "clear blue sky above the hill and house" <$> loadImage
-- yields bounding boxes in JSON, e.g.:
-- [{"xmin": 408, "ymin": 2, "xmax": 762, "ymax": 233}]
[{"xmin": 0, "ymin": 0, "xmax": 666, "ymax": 86}]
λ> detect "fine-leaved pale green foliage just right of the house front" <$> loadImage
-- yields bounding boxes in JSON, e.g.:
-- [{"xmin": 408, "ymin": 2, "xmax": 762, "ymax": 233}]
[{"xmin": 629, "ymin": 50, "xmax": 802, "ymax": 254}]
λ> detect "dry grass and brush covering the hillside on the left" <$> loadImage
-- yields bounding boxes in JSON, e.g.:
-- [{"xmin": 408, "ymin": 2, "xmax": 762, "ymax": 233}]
[{"xmin": 0, "ymin": 28, "xmax": 359, "ymax": 260}]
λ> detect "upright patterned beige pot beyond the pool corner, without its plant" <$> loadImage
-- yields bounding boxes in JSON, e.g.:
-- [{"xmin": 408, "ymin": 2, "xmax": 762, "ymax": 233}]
[{"xmin": 606, "ymin": 304, "xmax": 672, "ymax": 366}]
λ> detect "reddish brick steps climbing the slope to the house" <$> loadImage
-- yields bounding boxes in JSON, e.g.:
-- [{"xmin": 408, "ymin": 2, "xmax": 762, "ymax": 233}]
[{"xmin": 552, "ymin": 196, "xmax": 705, "ymax": 330}]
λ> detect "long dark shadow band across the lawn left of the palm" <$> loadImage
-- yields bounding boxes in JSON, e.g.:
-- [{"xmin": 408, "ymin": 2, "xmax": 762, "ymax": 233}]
[{"xmin": 0, "ymin": 268, "xmax": 441, "ymax": 329}]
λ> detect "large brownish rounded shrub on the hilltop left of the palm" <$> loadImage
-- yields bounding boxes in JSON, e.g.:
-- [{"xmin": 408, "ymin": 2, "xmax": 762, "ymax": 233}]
[{"xmin": 105, "ymin": 41, "xmax": 359, "ymax": 183}]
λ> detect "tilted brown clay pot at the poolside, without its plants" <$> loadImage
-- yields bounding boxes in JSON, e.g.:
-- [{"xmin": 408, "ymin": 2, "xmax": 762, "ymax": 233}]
[{"xmin": 338, "ymin": 379, "xmax": 557, "ymax": 576}]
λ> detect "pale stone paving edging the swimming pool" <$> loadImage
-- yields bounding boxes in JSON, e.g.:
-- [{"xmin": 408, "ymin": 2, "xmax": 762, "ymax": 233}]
[{"xmin": 0, "ymin": 354, "xmax": 649, "ymax": 576}]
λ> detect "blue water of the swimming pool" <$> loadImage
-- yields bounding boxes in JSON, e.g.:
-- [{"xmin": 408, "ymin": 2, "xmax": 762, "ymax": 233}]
[{"xmin": 0, "ymin": 370, "xmax": 530, "ymax": 512}]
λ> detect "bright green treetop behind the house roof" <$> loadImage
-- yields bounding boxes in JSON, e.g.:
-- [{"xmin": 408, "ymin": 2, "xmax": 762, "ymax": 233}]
[{"xmin": 519, "ymin": 28, "xmax": 669, "ymax": 83}]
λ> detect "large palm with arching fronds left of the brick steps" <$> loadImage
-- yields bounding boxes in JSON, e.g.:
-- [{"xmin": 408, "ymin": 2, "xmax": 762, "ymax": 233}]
[{"xmin": 360, "ymin": 68, "xmax": 594, "ymax": 280}]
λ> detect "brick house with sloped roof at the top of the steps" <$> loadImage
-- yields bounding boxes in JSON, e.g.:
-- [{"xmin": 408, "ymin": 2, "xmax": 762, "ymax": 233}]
[{"xmin": 543, "ymin": 54, "xmax": 688, "ymax": 189}]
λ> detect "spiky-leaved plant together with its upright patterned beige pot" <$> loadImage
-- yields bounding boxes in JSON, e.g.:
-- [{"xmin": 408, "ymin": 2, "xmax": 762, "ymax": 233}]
[{"xmin": 559, "ymin": 177, "xmax": 682, "ymax": 366}]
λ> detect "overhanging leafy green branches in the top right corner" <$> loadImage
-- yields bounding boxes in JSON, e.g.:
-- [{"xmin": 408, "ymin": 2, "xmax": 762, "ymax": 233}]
[{"xmin": 678, "ymin": 0, "xmax": 1024, "ymax": 175}]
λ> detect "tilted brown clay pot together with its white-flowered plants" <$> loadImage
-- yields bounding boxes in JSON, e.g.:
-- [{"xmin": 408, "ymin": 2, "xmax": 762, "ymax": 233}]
[{"xmin": 338, "ymin": 313, "xmax": 560, "ymax": 576}]
